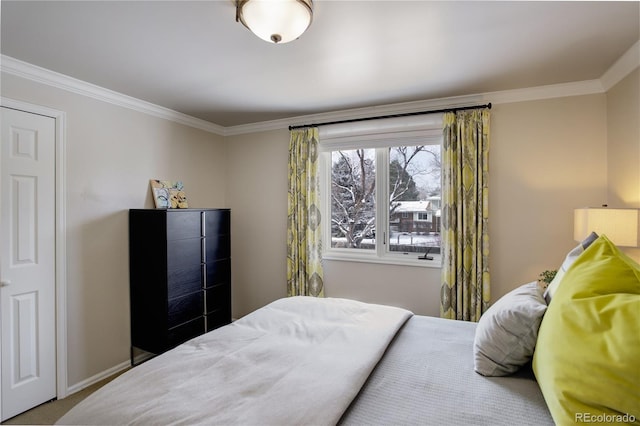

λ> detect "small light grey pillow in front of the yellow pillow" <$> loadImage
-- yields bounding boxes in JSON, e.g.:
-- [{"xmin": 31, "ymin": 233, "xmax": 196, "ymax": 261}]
[{"xmin": 473, "ymin": 281, "xmax": 547, "ymax": 376}]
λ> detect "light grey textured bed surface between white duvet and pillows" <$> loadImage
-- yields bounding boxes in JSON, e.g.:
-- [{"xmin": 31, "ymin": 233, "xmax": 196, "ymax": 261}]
[{"xmin": 341, "ymin": 316, "xmax": 553, "ymax": 426}]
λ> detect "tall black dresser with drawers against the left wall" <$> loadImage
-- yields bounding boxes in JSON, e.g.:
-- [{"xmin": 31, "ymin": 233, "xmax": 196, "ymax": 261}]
[{"xmin": 129, "ymin": 209, "xmax": 231, "ymax": 363}]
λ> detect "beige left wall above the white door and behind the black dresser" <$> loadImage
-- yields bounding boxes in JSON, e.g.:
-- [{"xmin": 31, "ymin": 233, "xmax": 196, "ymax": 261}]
[{"xmin": 2, "ymin": 74, "xmax": 227, "ymax": 386}]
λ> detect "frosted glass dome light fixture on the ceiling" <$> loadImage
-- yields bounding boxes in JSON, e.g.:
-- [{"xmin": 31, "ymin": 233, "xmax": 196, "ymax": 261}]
[{"xmin": 236, "ymin": 0, "xmax": 313, "ymax": 44}]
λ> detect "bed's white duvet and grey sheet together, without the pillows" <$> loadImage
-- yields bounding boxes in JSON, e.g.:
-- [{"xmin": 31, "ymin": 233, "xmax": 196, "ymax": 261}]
[{"xmin": 58, "ymin": 297, "xmax": 552, "ymax": 425}]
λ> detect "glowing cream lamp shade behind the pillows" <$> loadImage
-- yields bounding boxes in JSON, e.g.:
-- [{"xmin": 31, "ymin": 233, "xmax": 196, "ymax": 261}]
[{"xmin": 573, "ymin": 207, "xmax": 640, "ymax": 247}]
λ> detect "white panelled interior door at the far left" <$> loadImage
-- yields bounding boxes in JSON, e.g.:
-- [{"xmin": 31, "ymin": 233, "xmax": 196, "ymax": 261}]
[{"xmin": 0, "ymin": 107, "xmax": 56, "ymax": 420}]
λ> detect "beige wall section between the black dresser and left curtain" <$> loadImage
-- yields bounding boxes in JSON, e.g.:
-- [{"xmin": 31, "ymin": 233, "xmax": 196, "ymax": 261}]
[{"xmin": 222, "ymin": 129, "xmax": 289, "ymax": 318}]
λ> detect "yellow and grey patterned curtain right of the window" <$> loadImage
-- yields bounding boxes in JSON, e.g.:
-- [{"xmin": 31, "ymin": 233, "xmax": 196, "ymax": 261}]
[{"xmin": 440, "ymin": 109, "xmax": 490, "ymax": 321}]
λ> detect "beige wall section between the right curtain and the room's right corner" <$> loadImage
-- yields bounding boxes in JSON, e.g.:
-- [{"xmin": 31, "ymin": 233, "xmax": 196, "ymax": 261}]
[{"xmin": 489, "ymin": 95, "xmax": 607, "ymax": 301}]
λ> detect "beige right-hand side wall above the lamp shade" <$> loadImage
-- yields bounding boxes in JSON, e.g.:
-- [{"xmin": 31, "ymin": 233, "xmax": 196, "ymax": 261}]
[{"xmin": 607, "ymin": 68, "xmax": 640, "ymax": 262}]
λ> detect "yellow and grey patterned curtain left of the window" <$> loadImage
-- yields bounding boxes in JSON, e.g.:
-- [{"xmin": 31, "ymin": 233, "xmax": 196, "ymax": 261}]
[{"xmin": 287, "ymin": 127, "xmax": 324, "ymax": 297}]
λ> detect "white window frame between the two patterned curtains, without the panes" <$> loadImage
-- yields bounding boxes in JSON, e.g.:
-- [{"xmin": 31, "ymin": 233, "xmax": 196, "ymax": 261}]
[{"xmin": 319, "ymin": 114, "xmax": 443, "ymax": 268}]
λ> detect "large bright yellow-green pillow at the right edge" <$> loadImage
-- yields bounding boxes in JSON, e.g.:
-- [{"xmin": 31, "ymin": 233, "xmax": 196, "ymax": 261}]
[{"xmin": 533, "ymin": 236, "xmax": 640, "ymax": 425}]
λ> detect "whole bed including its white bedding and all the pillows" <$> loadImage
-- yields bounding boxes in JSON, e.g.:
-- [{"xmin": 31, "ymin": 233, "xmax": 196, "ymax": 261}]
[{"xmin": 58, "ymin": 235, "xmax": 640, "ymax": 425}]
